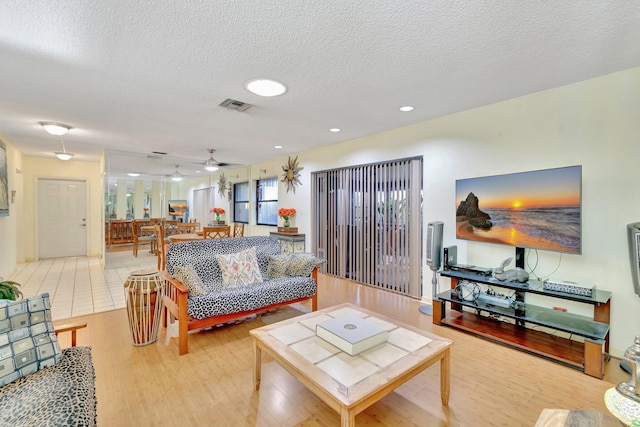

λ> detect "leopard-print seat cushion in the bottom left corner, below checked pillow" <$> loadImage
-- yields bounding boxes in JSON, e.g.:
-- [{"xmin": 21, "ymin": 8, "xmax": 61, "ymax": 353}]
[{"xmin": 0, "ymin": 347, "xmax": 97, "ymax": 427}]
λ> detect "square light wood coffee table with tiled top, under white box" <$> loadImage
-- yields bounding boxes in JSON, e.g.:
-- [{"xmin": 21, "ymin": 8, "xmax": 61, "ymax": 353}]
[{"xmin": 250, "ymin": 304, "xmax": 453, "ymax": 426}]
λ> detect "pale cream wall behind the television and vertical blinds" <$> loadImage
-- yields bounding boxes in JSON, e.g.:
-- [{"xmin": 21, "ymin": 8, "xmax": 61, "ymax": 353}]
[{"xmin": 252, "ymin": 68, "xmax": 640, "ymax": 356}]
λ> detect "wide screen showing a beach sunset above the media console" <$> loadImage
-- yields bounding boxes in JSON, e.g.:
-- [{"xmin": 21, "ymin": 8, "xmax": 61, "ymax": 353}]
[{"xmin": 456, "ymin": 166, "xmax": 582, "ymax": 254}]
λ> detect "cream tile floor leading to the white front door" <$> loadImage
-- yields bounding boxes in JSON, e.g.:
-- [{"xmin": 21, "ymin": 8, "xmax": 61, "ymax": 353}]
[{"xmin": 8, "ymin": 250, "xmax": 157, "ymax": 320}]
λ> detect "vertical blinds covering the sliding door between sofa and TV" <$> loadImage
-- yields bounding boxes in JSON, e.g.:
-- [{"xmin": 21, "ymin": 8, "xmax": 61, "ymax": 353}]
[{"xmin": 312, "ymin": 158, "xmax": 422, "ymax": 297}]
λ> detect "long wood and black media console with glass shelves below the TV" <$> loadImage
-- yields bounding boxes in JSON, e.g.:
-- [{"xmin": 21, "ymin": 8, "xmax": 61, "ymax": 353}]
[{"xmin": 433, "ymin": 269, "xmax": 611, "ymax": 378}]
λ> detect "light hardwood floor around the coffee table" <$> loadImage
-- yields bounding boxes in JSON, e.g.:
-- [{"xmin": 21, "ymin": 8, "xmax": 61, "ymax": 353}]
[{"xmin": 56, "ymin": 274, "xmax": 628, "ymax": 427}]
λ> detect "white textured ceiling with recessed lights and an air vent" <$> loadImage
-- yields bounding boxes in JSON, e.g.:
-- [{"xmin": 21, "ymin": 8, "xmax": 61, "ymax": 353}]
[{"xmin": 0, "ymin": 0, "xmax": 640, "ymax": 179}]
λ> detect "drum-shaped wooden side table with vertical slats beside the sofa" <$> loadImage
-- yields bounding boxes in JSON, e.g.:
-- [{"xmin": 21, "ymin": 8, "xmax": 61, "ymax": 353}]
[{"xmin": 124, "ymin": 270, "xmax": 164, "ymax": 346}]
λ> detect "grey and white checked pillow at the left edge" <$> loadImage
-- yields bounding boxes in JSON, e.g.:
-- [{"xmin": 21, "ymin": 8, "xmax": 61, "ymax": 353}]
[{"xmin": 0, "ymin": 293, "xmax": 61, "ymax": 387}]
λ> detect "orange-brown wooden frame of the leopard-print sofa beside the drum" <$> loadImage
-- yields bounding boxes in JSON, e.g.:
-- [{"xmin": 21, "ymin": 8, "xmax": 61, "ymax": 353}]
[{"xmin": 161, "ymin": 266, "xmax": 320, "ymax": 356}]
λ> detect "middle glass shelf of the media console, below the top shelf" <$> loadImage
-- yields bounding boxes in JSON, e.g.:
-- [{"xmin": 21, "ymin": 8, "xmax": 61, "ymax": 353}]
[{"xmin": 437, "ymin": 290, "xmax": 609, "ymax": 340}]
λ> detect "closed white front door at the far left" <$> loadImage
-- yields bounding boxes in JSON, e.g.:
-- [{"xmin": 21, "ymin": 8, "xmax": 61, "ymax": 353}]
[{"xmin": 38, "ymin": 179, "xmax": 87, "ymax": 259}]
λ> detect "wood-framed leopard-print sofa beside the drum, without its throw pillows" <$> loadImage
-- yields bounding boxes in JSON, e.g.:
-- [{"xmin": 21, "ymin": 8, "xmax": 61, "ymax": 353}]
[{"xmin": 163, "ymin": 236, "xmax": 317, "ymax": 354}]
